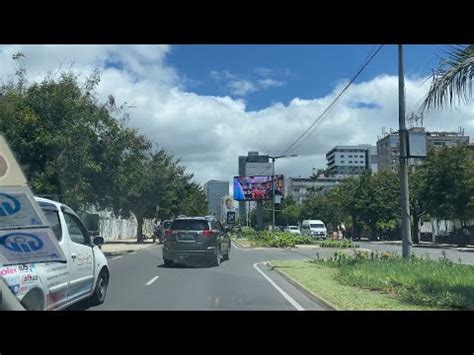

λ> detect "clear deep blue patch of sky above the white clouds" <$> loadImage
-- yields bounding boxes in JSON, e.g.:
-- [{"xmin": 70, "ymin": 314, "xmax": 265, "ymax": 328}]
[{"xmin": 167, "ymin": 45, "xmax": 446, "ymax": 110}]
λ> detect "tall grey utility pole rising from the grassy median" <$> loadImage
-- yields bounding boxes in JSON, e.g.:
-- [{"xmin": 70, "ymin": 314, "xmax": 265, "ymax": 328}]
[{"xmin": 398, "ymin": 44, "xmax": 411, "ymax": 259}]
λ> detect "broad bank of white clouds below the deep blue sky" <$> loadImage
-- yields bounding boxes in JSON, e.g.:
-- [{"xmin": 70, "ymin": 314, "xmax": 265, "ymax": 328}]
[{"xmin": 0, "ymin": 46, "xmax": 474, "ymax": 191}]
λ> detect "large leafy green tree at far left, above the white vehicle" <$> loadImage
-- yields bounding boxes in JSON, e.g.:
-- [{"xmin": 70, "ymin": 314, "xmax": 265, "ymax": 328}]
[{"xmin": 0, "ymin": 70, "xmax": 124, "ymax": 209}]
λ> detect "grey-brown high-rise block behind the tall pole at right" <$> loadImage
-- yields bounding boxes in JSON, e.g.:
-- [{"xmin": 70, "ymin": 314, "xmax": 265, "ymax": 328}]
[{"xmin": 377, "ymin": 127, "xmax": 469, "ymax": 171}]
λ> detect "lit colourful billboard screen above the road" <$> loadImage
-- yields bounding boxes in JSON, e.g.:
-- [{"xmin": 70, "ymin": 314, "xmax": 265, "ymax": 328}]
[{"xmin": 234, "ymin": 175, "xmax": 283, "ymax": 201}]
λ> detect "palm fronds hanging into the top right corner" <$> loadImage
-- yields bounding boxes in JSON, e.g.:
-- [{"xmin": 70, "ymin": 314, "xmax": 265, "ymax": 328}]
[{"xmin": 422, "ymin": 45, "xmax": 474, "ymax": 110}]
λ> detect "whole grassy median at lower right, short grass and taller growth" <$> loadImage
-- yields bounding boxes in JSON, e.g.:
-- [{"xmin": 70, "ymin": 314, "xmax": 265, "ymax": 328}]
[{"xmin": 272, "ymin": 252, "xmax": 474, "ymax": 310}]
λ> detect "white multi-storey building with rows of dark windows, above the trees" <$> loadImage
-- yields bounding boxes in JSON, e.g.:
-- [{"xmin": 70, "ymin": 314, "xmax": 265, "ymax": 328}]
[{"xmin": 326, "ymin": 144, "xmax": 376, "ymax": 176}]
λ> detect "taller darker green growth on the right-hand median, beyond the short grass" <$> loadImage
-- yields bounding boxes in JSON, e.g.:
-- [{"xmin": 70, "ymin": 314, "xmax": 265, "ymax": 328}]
[{"xmin": 312, "ymin": 251, "xmax": 474, "ymax": 309}]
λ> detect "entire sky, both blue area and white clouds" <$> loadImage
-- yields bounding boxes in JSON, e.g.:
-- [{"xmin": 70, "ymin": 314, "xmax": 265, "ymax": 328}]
[{"xmin": 0, "ymin": 45, "xmax": 474, "ymax": 183}]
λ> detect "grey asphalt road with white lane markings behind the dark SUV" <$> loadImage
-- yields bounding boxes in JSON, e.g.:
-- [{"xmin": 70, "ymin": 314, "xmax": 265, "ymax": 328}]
[{"xmin": 91, "ymin": 246, "xmax": 336, "ymax": 310}]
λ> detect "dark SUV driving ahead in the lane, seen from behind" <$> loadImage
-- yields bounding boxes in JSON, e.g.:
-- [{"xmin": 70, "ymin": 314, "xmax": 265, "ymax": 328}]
[{"xmin": 163, "ymin": 217, "xmax": 230, "ymax": 266}]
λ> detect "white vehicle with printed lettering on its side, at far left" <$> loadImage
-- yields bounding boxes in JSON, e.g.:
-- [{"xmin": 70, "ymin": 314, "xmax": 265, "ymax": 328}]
[{"xmin": 0, "ymin": 197, "xmax": 110, "ymax": 310}]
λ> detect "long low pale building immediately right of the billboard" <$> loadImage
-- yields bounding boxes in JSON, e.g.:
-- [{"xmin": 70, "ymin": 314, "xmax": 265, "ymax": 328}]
[{"xmin": 286, "ymin": 176, "xmax": 343, "ymax": 205}]
